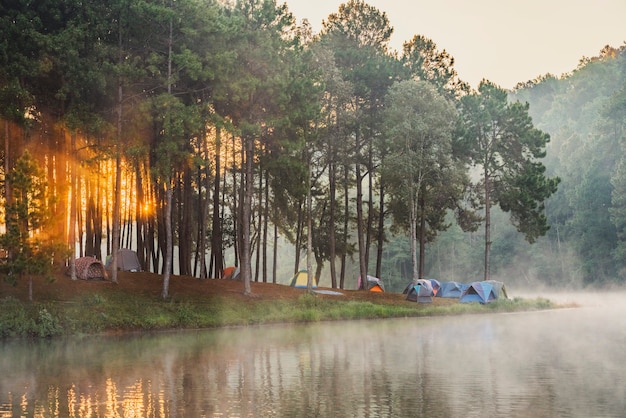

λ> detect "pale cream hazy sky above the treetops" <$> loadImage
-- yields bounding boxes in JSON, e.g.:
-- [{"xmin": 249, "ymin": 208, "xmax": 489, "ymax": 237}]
[{"xmin": 277, "ymin": 0, "xmax": 626, "ymax": 89}]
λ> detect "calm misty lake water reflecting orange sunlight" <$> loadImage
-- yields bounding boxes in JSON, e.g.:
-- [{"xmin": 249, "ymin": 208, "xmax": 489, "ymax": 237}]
[{"xmin": 0, "ymin": 297, "xmax": 626, "ymax": 418}]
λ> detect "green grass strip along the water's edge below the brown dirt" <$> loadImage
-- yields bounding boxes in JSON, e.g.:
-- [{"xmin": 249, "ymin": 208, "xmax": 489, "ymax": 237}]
[{"xmin": 0, "ymin": 291, "xmax": 556, "ymax": 338}]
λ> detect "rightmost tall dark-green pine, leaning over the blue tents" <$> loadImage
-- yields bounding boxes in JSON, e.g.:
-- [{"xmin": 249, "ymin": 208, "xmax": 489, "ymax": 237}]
[{"xmin": 461, "ymin": 80, "xmax": 560, "ymax": 280}]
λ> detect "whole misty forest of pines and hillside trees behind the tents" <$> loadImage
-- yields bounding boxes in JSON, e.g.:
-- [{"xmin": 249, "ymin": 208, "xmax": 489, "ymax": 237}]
[{"xmin": 0, "ymin": 0, "xmax": 626, "ymax": 297}]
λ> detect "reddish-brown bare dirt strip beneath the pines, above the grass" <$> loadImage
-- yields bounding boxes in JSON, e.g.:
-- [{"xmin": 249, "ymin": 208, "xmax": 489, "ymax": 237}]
[{"xmin": 0, "ymin": 272, "xmax": 456, "ymax": 305}]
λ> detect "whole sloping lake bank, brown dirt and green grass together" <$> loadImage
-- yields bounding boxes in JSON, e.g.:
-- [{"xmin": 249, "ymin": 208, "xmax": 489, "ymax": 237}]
[{"xmin": 0, "ymin": 272, "xmax": 555, "ymax": 338}]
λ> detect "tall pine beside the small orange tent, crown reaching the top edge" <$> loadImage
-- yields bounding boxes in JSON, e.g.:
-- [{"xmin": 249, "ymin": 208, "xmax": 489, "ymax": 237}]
[{"xmin": 216, "ymin": 0, "xmax": 298, "ymax": 294}]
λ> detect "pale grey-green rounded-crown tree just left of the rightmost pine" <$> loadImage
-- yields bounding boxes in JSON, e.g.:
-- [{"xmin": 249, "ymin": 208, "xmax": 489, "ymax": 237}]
[{"xmin": 384, "ymin": 80, "xmax": 456, "ymax": 283}]
